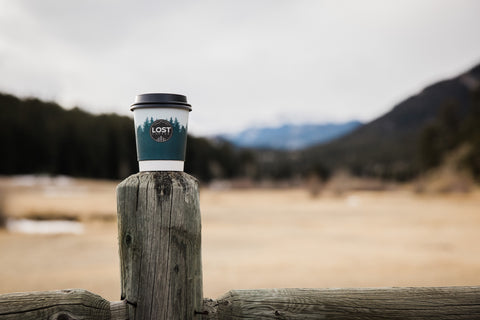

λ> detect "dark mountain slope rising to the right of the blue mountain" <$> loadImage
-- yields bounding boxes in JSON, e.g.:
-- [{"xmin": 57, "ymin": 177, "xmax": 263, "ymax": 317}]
[{"xmin": 301, "ymin": 61, "xmax": 480, "ymax": 180}]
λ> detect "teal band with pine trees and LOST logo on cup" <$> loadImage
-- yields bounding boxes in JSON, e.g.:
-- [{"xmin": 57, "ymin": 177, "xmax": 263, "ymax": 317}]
[{"xmin": 137, "ymin": 117, "xmax": 187, "ymax": 161}]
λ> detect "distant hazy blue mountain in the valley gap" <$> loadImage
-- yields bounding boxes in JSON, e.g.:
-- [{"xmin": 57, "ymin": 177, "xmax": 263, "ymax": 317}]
[{"xmin": 219, "ymin": 121, "xmax": 362, "ymax": 150}]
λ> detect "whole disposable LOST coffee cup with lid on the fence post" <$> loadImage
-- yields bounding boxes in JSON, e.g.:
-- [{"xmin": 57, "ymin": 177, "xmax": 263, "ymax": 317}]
[{"xmin": 130, "ymin": 93, "xmax": 192, "ymax": 171}]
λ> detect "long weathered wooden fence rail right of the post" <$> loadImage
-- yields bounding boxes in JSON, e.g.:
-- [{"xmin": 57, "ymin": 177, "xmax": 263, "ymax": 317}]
[{"xmin": 204, "ymin": 287, "xmax": 480, "ymax": 320}]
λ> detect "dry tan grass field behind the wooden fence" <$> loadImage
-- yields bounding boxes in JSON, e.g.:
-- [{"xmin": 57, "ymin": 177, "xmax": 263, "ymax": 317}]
[{"xmin": 0, "ymin": 177, "xmax": 480, "ymax": 300}]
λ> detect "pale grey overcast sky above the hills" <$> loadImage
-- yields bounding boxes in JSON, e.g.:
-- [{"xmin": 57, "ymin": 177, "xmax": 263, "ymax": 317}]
[{"xmin": 0, "ymin": 0, "xmax": 480, "ymax": 135}]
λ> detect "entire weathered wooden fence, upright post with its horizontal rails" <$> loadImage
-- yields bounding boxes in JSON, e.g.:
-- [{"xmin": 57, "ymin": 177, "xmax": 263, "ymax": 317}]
[{"xmin": 0, "ymin": 172, "xmax": 480, "ymax": 320}]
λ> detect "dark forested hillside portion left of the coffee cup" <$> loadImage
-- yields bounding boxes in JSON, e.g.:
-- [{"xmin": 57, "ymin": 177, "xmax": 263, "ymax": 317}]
[{"xmin": 0, "ymin": 93, "xmax": 137, "ymax": 179}]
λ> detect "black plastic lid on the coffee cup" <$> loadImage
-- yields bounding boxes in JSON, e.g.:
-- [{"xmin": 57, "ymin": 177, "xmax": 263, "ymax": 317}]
[{"xmin": 130, "ymin": 93, "xmax": 192, "ymax": 111}]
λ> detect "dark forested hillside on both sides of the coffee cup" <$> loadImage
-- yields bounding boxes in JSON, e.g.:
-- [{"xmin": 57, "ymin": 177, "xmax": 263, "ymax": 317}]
[{"xmin": 0, "ymin": 93, "xmax": 255, "ymax": 181}]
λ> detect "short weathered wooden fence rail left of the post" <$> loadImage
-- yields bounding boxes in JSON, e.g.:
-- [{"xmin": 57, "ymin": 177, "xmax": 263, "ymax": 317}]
[{"xmin": 0, "ymin": 289, "xmax": 120, "ymax": 320}]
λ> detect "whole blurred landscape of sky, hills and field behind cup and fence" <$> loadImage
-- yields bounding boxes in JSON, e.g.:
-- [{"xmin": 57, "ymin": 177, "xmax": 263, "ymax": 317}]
[{"xmin": 0, "ymin": 0, "xmax": 480, "ymax": 300}]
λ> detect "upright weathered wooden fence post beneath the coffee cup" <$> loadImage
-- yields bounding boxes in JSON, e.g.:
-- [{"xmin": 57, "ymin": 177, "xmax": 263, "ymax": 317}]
[{"xmin": 117, "ymin": 172, "xmax": 203, "ymax": 320}]
